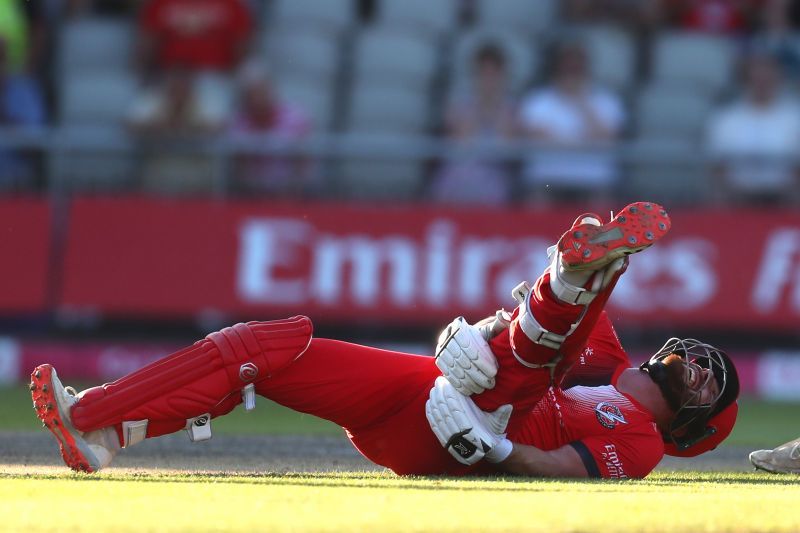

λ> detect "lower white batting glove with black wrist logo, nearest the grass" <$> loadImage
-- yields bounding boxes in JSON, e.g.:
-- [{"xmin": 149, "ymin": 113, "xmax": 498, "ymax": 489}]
[{"xmin": 425, "ymin": 377, "xmax": 513, "ymax": 465}]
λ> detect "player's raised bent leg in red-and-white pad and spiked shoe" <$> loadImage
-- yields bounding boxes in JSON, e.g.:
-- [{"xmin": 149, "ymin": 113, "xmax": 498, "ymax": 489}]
[{"xmin": 474, "ymin": 202, "xmax": 670, "ymax": 414}]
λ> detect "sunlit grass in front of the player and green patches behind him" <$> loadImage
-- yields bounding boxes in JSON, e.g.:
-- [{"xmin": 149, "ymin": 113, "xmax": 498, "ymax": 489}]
[{"xmin": 0, "ymin": 387, "xmax": 800, "ymax": 533}]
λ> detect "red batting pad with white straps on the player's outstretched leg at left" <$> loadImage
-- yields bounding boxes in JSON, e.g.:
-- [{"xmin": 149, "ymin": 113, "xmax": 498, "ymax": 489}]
[{"xmin": 71, "ymin": 316, "xmax": 313, "ymax": 446}]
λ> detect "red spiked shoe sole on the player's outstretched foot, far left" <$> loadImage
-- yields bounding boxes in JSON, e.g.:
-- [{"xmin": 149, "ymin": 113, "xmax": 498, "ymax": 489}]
[{"xmin": 30, "ymin": 364, "xmax": 99, "ymax": 473}]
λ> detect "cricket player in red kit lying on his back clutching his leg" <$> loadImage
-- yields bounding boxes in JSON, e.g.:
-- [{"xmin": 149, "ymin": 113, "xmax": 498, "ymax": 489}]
[{"xmin": 31, "ymin": 202, "xmax": 739, "ymax": 478}]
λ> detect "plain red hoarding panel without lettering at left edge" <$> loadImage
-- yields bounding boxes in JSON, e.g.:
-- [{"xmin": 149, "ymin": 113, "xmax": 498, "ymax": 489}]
[{"xmin": 0, "ymin": 198, "xmax": 52, "ymax": 315}]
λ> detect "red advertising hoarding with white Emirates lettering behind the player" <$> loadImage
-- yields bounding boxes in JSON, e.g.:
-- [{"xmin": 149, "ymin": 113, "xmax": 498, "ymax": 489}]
[{"xmin": 61, "ymin": 198, "xmax": 800, "ymax": 330}]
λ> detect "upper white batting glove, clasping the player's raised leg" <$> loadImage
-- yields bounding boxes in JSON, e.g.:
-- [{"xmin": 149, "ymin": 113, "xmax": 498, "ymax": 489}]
[{"xmin": 436, "ymin": 317, "xmax": 498, "ymax": 396}]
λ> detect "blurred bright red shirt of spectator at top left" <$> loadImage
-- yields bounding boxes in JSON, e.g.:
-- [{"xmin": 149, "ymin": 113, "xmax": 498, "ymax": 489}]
[{"xmin": 139, "ymin": 0, "xmax": 252, "ymax": 77}]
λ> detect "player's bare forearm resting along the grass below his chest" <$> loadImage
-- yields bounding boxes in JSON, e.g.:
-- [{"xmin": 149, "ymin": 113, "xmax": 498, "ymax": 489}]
[{"xmin": 497, "ymin": 442, "xmax": 589, "ymax": 477}]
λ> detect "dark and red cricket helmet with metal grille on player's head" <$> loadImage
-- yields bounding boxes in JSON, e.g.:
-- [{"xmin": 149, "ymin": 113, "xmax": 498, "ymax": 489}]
[{"xmin": 639, "ymin": 337, "xmax": 739, "ymax": 457}]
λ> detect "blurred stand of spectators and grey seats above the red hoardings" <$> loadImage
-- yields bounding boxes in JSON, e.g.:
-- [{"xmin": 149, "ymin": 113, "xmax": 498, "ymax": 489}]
[{"xmin": 0, "ymin": 0, "xmax": 800, "ymax": 206}]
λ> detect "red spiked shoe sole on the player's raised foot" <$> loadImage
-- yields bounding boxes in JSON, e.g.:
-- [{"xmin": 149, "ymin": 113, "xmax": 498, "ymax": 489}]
[{"xmin": 558, "ymin": 202, "xmax": 672, "ymax": 270}]
